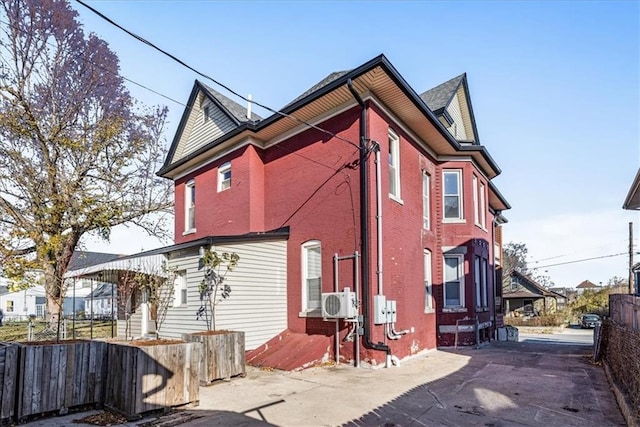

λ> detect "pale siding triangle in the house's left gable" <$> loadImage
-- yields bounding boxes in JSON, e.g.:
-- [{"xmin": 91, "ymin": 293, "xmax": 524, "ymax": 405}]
[{"xmin": 171, "ymin": 94, "xmax": 236, "ymax": 162}]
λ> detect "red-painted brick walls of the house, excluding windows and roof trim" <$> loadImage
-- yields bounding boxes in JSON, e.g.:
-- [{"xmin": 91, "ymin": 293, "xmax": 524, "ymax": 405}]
[{"xmin": 176, "ymin": 100, "xmax": 502, "ymax": 362}]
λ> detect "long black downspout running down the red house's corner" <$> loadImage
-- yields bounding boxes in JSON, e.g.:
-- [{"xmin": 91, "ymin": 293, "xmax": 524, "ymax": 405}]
[{"xmin": 347, "ymin": 79, "xmax": 392, "ymax": 367}]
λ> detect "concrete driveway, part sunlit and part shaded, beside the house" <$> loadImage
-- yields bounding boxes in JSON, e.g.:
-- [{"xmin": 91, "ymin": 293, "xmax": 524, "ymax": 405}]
[{"xmin": 26, "ymin": 330, "xmax": 625, "ymax": 427}]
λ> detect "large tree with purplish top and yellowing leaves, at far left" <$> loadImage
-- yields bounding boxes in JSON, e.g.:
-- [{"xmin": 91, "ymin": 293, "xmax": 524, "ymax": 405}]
[{"xmin": 0, "ymin": 0, "xmax": 172, "ymax": 334}]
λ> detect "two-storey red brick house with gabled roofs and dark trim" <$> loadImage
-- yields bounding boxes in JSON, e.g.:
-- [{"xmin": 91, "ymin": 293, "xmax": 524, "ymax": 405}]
[{"xmin": 158, "ymin": 55, "xmax": 510, "ymax": 369}]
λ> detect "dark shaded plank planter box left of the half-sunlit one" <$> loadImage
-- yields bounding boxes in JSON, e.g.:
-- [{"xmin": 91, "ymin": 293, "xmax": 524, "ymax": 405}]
[{"xmin": 16, "ymin": 341, "xmax": 107, "ymax": 419}]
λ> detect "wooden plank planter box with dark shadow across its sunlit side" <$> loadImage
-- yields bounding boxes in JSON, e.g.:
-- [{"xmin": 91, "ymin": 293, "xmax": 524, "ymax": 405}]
[{"xmin": 104, "ymin": 342, "xmax": 201, "ymax": 418}]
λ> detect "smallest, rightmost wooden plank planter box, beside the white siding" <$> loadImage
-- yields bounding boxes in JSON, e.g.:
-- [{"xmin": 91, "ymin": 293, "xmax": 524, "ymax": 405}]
[{"xmin": 182, "ymin": 331, "xmax": 246, "ymax": 385}]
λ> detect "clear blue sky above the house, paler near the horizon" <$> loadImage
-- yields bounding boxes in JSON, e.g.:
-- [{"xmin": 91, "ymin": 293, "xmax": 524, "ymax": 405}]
[{"xmin": 72, "ymin": 1, "xmax": 640, "ymax": 286}]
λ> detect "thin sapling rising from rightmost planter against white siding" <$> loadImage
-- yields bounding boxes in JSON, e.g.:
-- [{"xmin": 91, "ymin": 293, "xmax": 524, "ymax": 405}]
[{"xmin": 196, "ymin": 249, "xmax": 240, "ymax": 331}]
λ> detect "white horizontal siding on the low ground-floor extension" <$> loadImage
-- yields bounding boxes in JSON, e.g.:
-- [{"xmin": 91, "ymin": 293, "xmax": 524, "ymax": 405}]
[{"xmin": 118, "ymin": 241, "xmax": 287, "ymax": 350}]
